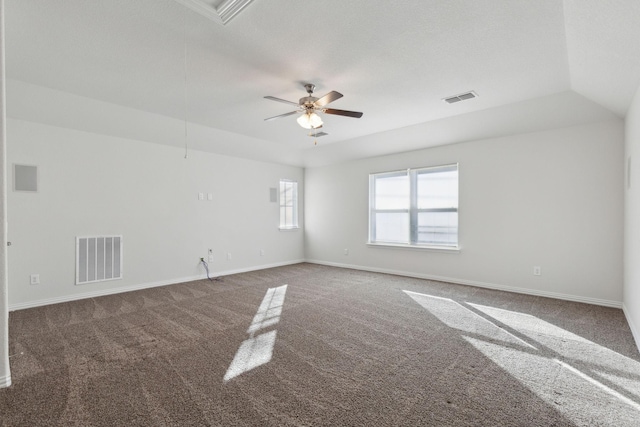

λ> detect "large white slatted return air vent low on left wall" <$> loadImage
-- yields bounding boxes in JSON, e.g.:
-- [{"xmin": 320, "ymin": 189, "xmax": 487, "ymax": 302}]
[{"xmin": 76, "ymin": 236, "xmax": 122, "ymax": 285}]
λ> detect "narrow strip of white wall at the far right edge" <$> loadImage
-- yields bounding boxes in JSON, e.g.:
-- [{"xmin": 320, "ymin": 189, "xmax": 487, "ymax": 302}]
[{"xmin": 624, "ymin": 83, "xmax": 640, "ymax": 348}]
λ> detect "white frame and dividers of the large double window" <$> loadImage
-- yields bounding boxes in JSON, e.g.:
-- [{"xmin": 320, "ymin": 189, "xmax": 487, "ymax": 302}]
[{"xmin": 367, "ymin": 163, "xmax": 460, "ymax": 251}]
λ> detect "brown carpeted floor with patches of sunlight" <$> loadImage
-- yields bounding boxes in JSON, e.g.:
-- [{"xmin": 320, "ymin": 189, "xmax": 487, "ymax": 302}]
[{"xmin": 0, "ymin": 264, "xmax": 640, "ymax": 427}]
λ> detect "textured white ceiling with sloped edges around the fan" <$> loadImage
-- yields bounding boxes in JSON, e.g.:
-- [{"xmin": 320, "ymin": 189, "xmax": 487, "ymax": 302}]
[{"xmin": 5, "ymin": 0, "xmax": 640, "ymax": 166}]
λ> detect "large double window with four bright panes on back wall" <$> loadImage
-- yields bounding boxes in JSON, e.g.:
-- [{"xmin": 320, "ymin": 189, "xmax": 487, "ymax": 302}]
[{"xmin": 369, "ymin": 164, "xmax": 458, "ymax": 247}]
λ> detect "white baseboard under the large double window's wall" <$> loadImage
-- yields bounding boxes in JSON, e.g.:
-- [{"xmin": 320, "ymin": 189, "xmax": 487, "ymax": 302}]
[{"xmin": 305, "ymin": 259, "xmax": 624, "ymax": 310}]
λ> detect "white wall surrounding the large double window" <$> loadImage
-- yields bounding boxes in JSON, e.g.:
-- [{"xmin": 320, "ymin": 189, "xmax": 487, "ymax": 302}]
[{"xmin": 305, "ymin": 120, "xmax": 624, "ymax": 307}]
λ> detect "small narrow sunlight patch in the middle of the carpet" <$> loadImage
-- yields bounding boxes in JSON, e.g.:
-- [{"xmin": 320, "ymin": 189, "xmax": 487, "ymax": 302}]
[{"xmin": 224, "ymin": 285, "xmax": 287, "ymax": 382}]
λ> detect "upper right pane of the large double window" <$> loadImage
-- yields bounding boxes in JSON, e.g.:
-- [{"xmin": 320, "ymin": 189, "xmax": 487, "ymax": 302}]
[{"xmin": 418, "ymin": 170, "xmax": 458, "ymax": 209}]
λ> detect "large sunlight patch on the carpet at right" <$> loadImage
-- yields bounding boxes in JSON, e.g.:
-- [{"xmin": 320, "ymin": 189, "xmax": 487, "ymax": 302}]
[{"xmin": 404, "ymin": 291, "xmax": 640, "ymax": 425}]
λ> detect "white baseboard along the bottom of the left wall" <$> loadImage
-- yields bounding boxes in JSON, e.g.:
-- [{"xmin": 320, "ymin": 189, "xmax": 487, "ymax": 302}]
[{"xmin": 9, "ymin": 259, "xmax": 304, "ymax": 311}]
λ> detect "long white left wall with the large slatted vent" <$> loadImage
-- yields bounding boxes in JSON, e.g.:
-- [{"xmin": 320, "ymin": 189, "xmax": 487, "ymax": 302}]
[{"xmin": 8, "ymin": 119, "xmax": 304, "ymax": 309}]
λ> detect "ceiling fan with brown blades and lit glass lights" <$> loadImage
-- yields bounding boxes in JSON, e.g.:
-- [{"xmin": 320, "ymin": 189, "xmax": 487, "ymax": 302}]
[{"xmin": 264, "ymin": 83, "xmax": 362, "ymax": 129}]
